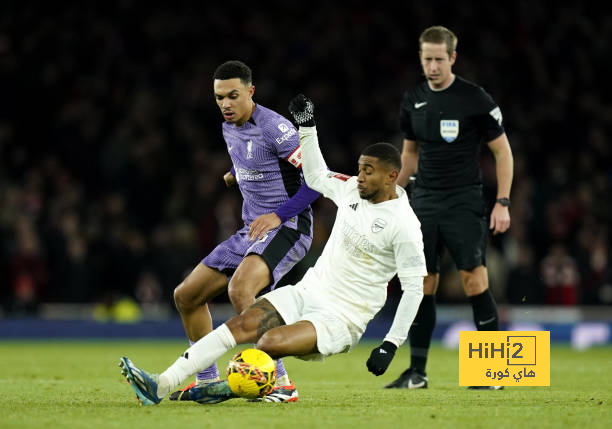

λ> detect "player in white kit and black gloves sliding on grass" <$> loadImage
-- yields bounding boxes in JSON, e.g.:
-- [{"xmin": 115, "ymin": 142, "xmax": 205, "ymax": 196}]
[{"xmin": 120, "ymin": 94, "xmax": 427, "ymax": 405}]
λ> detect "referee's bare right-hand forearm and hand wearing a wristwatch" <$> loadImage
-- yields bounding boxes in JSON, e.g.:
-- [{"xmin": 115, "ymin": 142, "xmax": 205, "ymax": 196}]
[{"xmin": 488, "ymin": 133, "xmax": 514, "ymax": 235}]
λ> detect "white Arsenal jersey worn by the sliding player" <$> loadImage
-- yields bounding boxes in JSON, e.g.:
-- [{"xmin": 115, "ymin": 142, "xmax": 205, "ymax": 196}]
[{"xmin": 299, "ymin": 127, "xmax": 427, "ymax": 330}]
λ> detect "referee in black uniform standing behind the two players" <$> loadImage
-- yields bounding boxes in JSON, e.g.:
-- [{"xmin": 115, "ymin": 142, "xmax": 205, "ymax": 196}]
[{"xmin": 385, "ymin": 26, "xmax": 513, "ymax": 389}]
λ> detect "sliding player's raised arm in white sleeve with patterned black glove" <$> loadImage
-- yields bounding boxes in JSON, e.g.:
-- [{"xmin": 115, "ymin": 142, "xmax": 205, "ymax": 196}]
[{"xmin": 289, "ymin": 94, "xmax": 348, "ymax": 201}]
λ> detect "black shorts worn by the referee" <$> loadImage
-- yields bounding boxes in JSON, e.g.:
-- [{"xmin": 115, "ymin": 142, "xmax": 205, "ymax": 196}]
[{"xmin": 410, "ymin": 185, "xmax": 488, "ymax": 274}]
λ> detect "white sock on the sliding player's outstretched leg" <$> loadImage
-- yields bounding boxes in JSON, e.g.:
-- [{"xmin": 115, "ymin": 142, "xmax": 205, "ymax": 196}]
[{"xmin": 157, "ymin": 324, "xmax": 236, "ymax": 398}]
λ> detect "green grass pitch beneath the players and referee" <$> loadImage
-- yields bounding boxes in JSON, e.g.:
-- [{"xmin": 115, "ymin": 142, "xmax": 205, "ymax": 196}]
[{"xmin": 0, "ymin": 341, "xmax": 612, "ymax": 429}]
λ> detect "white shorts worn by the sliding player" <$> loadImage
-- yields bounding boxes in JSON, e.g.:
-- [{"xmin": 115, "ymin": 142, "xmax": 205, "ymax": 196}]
[{"xmin": 262, "ymin": 282, "xmax": 363, "ymax": 360}]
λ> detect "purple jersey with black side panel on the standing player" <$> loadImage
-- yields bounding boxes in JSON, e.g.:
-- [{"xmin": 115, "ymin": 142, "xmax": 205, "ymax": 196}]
[{"xmin": 222, "ymin": 104, "xmax": 312, "ymax": 234}]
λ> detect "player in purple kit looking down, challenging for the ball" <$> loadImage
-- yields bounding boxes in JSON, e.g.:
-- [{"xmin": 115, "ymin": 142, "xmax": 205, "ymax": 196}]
[{"xmin": 170, "ymin": 61, "xmax": 320, "ymax": 402}]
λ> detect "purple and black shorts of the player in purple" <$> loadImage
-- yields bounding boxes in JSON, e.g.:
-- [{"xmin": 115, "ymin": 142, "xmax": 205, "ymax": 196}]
[{"xmin": 202, "ymin": 225, "xmax": 312, "ymax": 289}]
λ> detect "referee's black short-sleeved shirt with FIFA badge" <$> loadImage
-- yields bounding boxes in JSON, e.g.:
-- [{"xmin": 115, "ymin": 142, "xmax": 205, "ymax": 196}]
[{"xmin": 400, "ymin": 76, "xmax": 504, "ymax": 189}]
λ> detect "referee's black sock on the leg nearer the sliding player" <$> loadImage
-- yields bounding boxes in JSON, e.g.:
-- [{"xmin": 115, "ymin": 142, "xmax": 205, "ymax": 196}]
[{"xmin": 408, "ymin": 295, "xmax": 436, "ymax": 374}]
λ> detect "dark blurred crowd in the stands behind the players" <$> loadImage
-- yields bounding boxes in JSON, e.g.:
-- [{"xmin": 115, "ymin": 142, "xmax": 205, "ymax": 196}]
[{"xmin": 0, "ymin": 0, "xmax": 612, "ymax": 315}]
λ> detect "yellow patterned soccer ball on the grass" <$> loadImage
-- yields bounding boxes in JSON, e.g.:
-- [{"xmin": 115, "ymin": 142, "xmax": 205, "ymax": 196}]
[{"xmin": 225, "ymin": 349, "xmax": 276, "ymax": 399}]
